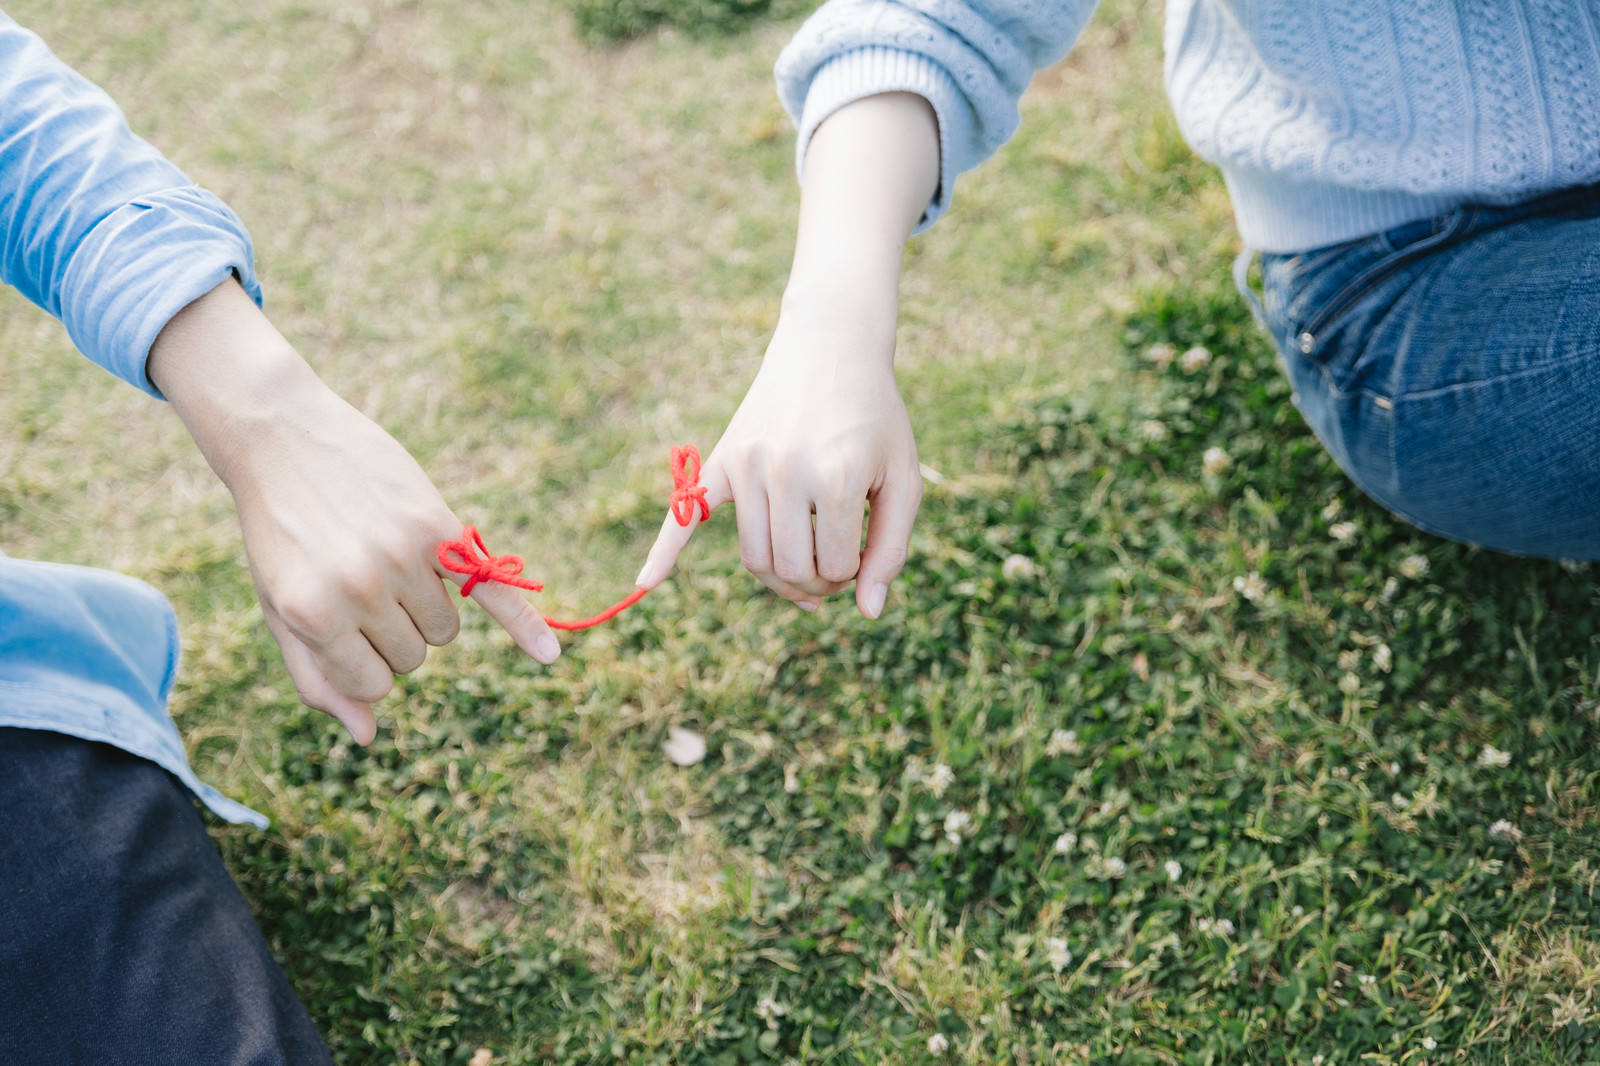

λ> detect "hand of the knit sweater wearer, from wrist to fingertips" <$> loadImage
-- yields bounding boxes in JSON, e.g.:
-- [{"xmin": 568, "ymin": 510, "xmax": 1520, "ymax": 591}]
[{"xmin": 638, "ymin": 299, "xmax": 922, "ymax": 618}]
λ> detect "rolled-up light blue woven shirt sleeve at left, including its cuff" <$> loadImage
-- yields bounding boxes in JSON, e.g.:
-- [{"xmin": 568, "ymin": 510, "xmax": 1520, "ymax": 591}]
[{"xmin": 0, "ymin": 14, "xmax": 261, "ymax": 397}]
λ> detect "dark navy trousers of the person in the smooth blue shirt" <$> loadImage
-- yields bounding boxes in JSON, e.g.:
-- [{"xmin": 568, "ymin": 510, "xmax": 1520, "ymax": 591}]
[{"xmin": 0, "ymin": 728, "xmax": 333, "ymax": 1066}]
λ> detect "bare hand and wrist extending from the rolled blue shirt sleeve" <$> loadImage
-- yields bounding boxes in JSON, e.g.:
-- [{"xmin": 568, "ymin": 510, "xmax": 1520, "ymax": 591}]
[{"xmin": 147, "ymin": 280, "xmax": 560, "ymax": 744}]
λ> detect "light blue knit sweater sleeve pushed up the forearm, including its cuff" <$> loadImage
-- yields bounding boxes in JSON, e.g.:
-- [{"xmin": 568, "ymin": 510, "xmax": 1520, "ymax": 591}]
[{"xmin": 776, "ymin": 0, "xmax": 1098, "ymax": 232}]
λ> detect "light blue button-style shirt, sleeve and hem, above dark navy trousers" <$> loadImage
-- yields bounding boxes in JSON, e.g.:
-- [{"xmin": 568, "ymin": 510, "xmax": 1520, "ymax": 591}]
[{"xmin": 0, "ymin": 14, "xmax": 267, "ymax": 826}]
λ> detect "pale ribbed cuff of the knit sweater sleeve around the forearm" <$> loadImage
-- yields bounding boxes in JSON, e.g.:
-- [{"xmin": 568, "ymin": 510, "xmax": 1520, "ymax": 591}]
[{"xmin": 795, "ymin": 46, "xmax": 976, "ymax": 234}]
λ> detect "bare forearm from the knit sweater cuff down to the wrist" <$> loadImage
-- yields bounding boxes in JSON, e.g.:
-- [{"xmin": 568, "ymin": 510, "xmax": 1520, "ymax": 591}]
[{"xmin": 784, "ymin": 93, "xmax": 939, "ymax": 328}]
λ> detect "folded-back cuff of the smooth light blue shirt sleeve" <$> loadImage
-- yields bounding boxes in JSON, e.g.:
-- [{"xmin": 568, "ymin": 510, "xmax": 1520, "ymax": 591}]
[{"xmin": 61, "ymin": 186, "xmax": 261, "ymax": 399}]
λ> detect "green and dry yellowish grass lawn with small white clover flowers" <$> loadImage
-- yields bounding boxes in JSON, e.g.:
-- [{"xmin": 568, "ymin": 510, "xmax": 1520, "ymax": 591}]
[{"xmin": 0, "ymin": 0, "xmax": 1600, "ymax": 1066}]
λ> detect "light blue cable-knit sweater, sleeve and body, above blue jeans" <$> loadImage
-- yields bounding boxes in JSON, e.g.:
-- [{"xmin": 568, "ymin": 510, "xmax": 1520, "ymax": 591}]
[{"xmin": 778, "ymin": 0, "xmax": 1600, "ymax": 251}]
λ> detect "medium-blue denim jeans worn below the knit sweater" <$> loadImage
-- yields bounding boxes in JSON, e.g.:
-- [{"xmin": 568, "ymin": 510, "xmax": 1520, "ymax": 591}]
[{"xmin": 1246, "ymin": 186, "xmax": 1600, "ymax": 559}]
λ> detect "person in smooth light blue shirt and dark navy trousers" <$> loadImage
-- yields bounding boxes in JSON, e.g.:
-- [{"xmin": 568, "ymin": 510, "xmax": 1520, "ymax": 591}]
[{"xmin": 0, "ymin": 14, "xmax": 560, "ymax": 1066}]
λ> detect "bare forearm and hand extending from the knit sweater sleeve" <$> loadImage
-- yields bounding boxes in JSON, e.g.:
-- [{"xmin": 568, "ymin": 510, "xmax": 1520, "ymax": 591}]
[{"xmin": 638, "ymin": 93, "xmax": 939, "ymax": 618}]
